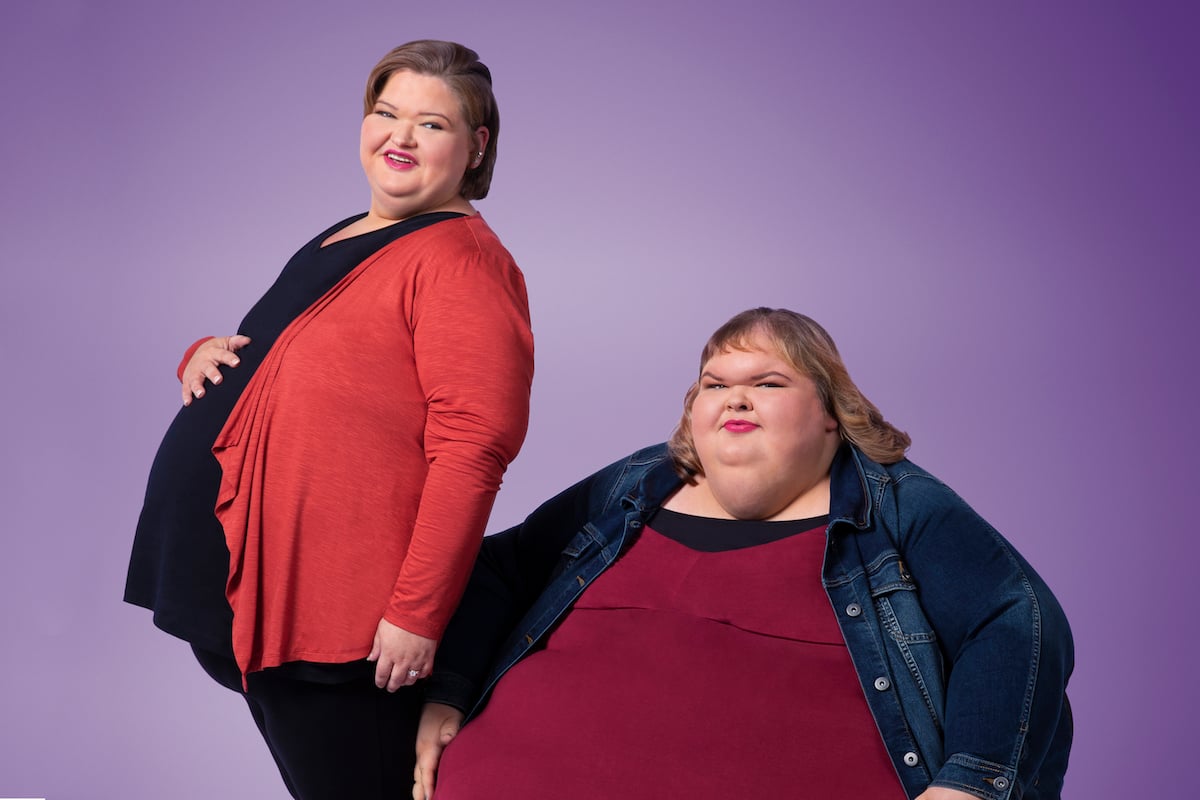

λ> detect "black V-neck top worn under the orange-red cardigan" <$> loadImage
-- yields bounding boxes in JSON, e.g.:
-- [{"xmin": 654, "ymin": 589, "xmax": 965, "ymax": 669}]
[{"xmin": 125, "ymin": 212, "xmax": 463, "ymax": 658}]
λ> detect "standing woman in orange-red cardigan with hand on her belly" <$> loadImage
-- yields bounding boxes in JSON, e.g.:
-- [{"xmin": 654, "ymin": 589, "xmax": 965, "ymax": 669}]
[{"xmin": 125, "ymin": 41, "xmax": 533, "ymax": 800}]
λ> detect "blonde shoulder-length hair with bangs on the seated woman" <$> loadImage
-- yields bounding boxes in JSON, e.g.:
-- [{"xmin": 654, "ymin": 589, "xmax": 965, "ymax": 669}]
[{"xmin": 667, "ymin": 308, "xmax": 912, "ymax": 479}]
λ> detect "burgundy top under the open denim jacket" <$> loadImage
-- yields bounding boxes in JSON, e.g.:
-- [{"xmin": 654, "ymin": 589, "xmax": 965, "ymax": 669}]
[{"xmin": 436, "ymin": 512, "xmax": 905, "ymax": 800}]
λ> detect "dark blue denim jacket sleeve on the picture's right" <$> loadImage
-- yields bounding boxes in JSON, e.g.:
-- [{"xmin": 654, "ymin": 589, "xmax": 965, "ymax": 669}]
[{"xmin": 882, "ymin": 474, "xmax": 1074, "ymax": 800}]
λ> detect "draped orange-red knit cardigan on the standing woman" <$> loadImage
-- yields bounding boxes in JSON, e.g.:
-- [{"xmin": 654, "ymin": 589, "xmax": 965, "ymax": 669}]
[{"xmin": 212, "ymin": 215, "xmax": 533, "ymax": 675}]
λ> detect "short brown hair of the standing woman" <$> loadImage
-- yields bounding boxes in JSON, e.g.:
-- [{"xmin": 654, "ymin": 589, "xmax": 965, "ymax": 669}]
[{"xmin": 362, "ymin": 38, "xmax": 500, "ymax": 200}]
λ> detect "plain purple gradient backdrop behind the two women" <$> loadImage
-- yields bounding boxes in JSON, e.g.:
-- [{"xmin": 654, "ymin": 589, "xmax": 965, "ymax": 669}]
[{"xmin": 0, "ymin": 0, "xmax": 1200, "ymax": 800}]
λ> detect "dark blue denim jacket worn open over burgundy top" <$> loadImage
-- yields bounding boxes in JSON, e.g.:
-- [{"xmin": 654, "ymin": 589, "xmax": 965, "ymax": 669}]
[{"xmin": 427, "ymin": 444, "xmax": 1073, "ymax": 800}]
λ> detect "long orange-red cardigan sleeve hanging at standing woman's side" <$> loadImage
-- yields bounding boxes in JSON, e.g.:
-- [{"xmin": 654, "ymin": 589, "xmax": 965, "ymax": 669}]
[{"xmin": 384, "ymin": 232, "xmax": 533, "ymax": 639}]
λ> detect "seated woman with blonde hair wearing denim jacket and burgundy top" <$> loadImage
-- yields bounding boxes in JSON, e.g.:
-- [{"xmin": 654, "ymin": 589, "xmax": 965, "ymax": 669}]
[{"xmin": 413, "ymin": 308, "xmax": 1073, "ymax": 800}]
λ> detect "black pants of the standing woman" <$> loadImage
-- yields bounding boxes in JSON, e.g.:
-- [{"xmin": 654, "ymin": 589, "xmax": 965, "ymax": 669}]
[{"xmin": 192, "ymin": 648, "xmax": 421, "ymax": 800}]
